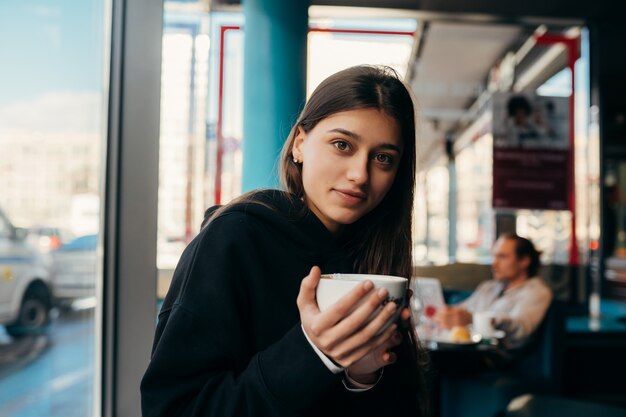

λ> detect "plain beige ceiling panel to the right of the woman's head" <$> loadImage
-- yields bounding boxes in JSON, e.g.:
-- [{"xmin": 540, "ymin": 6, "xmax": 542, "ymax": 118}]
[{"xmin": 408, "ymin": 21, "xmax": 532, "ymax": 167}]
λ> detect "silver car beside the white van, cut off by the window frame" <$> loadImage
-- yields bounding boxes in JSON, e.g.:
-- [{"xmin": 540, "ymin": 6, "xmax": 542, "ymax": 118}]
[{"xmin": 50, "ymin": 235, "xmax": 98, "ymax": 304}]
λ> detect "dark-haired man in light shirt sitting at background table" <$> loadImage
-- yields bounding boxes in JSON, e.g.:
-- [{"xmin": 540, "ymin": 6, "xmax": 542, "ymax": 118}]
[{"xmin": 435, "ymin": 234, "xmax": 552, "ymax": 348}]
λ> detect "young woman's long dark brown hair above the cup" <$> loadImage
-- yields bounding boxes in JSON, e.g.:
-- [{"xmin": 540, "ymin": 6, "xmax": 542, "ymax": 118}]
[{"xmin": 280, "ymin": 65, "xmax": 416, "ymax": 278}]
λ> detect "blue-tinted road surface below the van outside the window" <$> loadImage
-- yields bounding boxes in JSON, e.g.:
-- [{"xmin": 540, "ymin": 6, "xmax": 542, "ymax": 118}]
[{"xmin": 0, "ymin": 308, "xmax": 95, "ymax": 417}]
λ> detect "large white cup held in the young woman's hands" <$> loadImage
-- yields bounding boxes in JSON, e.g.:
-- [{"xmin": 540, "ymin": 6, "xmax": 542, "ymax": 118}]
[{"xmin": 316, "ymin": 274, "xmax": 409, "ymax": 334}]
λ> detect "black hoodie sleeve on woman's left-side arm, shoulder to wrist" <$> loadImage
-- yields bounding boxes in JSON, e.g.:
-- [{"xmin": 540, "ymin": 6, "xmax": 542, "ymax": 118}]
[{"xmin": 141, "ymin": 213, "xmax": 341, "ymax": 417}]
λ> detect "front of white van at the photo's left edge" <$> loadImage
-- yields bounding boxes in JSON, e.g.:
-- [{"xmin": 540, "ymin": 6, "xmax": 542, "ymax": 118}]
[{"xmin": 0, "ymin": 206, "xmax": 53, "ymax": 337}]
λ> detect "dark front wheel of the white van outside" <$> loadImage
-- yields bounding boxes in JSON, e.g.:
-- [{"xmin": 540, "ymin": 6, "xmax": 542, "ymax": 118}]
[{"xmin": 6, "ymin": 290, "xmax": 50, "ymax": 337}]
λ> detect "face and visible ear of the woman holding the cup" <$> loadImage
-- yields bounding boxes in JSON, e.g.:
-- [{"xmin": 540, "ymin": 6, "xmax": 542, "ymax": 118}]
[{"xmin": 292, "ymin": 109, "xmax": 403, "ymax": 233}]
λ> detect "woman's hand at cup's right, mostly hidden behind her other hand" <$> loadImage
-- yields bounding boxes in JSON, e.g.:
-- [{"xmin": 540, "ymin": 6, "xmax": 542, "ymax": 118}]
[{"xmin": 347, "ymin": 307, "xmax": 411, "ymax": 384}]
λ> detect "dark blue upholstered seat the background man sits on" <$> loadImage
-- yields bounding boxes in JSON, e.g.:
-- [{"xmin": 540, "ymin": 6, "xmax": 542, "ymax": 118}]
[{"xmin": 440, "ymin": 300, "xmax": 565, "ymax": 417}]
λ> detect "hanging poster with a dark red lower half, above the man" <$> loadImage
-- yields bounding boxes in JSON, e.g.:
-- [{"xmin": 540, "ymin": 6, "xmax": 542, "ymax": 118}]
[{"xmin": 492, "ymin": 93, "xmax": 570, "ymax": 210}]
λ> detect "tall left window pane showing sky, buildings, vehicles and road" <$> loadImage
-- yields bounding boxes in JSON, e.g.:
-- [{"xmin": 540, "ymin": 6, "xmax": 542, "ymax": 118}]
[{"xmin": 0, "ymin": 0, "xmax": 106, "ymax": 417}]
